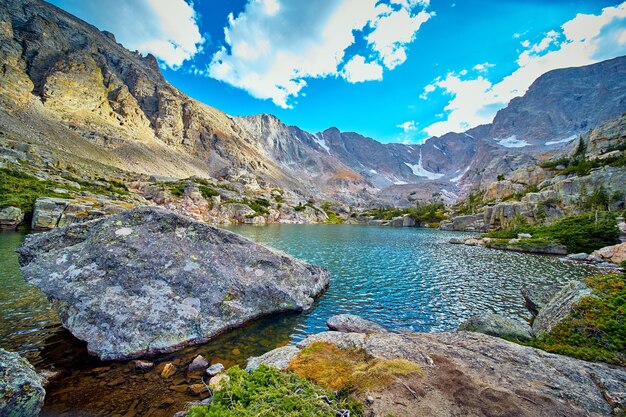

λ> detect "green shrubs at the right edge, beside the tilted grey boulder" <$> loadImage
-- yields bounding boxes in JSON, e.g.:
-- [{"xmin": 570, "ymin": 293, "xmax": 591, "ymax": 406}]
[{"xmin": 524, "ymin": 274, "xmax": 626, "ymax": 366}]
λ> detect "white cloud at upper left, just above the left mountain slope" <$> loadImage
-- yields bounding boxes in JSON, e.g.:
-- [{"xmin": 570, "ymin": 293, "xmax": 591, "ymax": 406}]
[{"xmin": 51, "ymin": 0, "xmax": 204, "ymax": 68}]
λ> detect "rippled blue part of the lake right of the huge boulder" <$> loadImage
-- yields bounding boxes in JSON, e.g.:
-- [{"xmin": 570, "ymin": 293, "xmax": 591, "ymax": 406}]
[{"xmin": 222, "ymin": 225, "xmax": 590, "ymax": 339}]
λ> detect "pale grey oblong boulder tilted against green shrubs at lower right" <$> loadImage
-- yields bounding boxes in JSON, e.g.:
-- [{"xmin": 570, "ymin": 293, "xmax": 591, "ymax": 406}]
[{"xmin": 533, "ymin": 281, "xmax": 592, "ymax": 337}]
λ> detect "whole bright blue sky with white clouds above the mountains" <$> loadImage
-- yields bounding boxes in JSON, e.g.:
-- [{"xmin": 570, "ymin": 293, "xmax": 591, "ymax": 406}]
[{"xmin": 52, "ymin": 0, "xmax": 626, "ymax": 143}]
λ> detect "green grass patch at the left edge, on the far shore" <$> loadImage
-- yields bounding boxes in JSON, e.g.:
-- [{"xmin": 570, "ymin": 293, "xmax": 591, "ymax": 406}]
[{"xmin": 0, "ymin": 168, "xmax": 71, "ymax": 214}]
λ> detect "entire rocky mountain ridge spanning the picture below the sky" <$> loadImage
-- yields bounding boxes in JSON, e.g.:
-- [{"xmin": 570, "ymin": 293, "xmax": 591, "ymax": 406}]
[{"xmin": 0, "ymin": 0, "xmax": 626, "ymax": 204}]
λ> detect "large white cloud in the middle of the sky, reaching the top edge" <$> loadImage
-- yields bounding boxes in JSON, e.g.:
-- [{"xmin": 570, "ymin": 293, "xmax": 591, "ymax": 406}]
[{"xmin": 208, "ymin": 0, "xmax": 430, "ymax": 108}]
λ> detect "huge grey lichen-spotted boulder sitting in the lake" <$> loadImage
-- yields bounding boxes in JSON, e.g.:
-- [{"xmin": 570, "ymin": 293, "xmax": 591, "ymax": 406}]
[{"xmin": 18, "ymin": 207, "xmax": 329, "ymax": 359}]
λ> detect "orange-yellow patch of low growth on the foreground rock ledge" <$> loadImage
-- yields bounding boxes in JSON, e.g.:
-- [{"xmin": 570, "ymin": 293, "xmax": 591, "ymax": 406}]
[{"xmin": 288, "ymin": 342, "xmax": 423, "ymax": 392}]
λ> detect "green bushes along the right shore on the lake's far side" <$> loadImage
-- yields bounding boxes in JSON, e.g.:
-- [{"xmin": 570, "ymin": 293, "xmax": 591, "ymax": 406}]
[{"xmin": 484, "ymin": 212, "xmax": 620, "ymax": 253}]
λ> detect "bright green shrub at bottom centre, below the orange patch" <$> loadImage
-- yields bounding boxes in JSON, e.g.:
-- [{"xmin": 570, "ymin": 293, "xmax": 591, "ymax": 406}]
[{"xmin": 187, "ymin": 365, "xmax": 363, "ymax": 417}]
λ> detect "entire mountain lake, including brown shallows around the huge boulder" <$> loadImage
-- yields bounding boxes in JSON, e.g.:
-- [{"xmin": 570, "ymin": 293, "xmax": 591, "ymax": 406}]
[{"xmin": 0, "ymin": 225, "xmax": 592, "ymax": 417}]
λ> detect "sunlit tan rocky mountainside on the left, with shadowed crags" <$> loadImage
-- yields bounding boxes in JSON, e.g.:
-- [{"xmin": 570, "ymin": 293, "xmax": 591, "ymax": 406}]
[{"xmin": 0, "ymin": 0, "xmax": 376, "ymax": 202}]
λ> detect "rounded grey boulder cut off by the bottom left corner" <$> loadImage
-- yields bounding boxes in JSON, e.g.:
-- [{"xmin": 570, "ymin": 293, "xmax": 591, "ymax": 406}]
[{"xmin": 0, "ymin": 349, "xmax": 46, "ymax": 417}]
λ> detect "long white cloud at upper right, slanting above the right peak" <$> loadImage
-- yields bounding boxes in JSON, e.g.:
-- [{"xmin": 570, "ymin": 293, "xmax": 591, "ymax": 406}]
[{"xmin": 421, "ymin": 2, "xmax": 626, "ymax": 136}]
